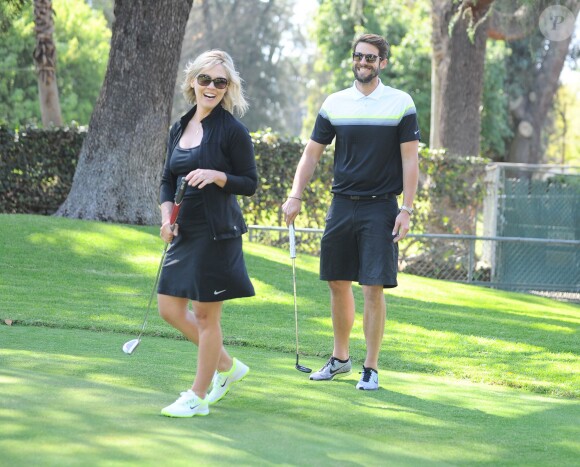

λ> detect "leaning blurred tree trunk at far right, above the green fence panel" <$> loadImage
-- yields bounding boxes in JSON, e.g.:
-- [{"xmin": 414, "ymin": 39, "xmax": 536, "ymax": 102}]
[{"xmin": 507, "ymin": 1, "xmax": 580, "ymax": 164}]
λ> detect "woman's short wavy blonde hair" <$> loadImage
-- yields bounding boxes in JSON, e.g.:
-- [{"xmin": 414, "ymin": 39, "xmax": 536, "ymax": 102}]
[{"xmin": 181, "ymin": 49, "xmax": 249, "ymax": 117}]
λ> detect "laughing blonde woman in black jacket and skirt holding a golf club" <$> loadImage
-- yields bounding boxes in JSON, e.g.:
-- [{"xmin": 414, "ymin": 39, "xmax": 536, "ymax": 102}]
[{"xmin": 157, "ymin": 50, "xmax": 258, "ymax": 417}]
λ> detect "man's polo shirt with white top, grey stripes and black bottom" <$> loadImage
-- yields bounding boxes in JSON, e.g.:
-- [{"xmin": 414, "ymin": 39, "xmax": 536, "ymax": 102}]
[{"xmin": 310, "ymin": 81, "xmax": 420, "ymax": 196}]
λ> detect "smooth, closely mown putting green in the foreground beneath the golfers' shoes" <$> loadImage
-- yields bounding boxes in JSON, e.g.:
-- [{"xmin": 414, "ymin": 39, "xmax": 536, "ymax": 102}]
[{"xmin": 0, "ymin": 326, "xmax": 580, "ymax": 465}]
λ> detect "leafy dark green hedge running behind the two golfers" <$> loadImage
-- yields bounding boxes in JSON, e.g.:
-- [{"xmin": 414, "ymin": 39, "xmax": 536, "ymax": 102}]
[{"xmin": 0, "ymin": 127, "xmax": 488, "ymax": 253}]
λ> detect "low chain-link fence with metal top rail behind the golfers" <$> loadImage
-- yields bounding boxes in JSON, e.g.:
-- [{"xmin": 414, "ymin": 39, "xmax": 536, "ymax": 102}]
[{"xmin": 249, "ymin": 225, "xmax": 580, "ymax": 303}]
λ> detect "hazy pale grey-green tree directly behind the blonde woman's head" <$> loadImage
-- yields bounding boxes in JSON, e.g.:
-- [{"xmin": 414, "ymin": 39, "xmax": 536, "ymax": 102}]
[{"xmin": 172, "ymin": 0, "xmax": 305, "ymax": 134}]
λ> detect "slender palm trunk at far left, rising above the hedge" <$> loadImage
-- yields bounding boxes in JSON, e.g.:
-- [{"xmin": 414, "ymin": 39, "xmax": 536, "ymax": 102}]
[{"xmin": 33, "ymin": 0, "xmax": 62, "ymax": 128}]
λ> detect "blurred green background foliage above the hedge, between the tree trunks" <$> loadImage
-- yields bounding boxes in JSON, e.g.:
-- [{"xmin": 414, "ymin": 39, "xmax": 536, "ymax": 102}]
[{"xmin": 0, "ymin": 0, "xmax": 580, "ymax": 164}]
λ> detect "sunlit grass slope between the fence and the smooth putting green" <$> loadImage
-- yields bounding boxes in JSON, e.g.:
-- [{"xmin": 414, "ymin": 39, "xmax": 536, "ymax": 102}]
[{"xmin": 0, "ymin": 215, "xmax": 580, "ymax": 398}]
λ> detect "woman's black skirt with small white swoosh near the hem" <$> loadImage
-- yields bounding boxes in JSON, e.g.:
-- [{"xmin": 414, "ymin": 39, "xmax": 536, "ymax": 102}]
[{"xmin": 157, "ymin": 196, "xmax": 255, "ymax": 302}]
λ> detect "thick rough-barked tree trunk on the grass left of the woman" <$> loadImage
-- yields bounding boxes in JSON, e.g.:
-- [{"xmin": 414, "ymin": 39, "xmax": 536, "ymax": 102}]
[{"xmin": 56, "ymin": 0, "xmax": 192, "ymax": 225}]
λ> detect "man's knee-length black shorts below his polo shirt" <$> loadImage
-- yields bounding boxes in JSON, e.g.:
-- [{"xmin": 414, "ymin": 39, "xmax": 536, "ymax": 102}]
[{"xmin": 320, "ymin": 195, "xmax": 399, "ymax": 288}]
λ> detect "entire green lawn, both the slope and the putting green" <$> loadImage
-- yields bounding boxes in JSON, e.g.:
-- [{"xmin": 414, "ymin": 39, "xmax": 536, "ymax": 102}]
[{"xmin": 0, "ymin": 215, "xmax": 580, "ymax": 465}]
